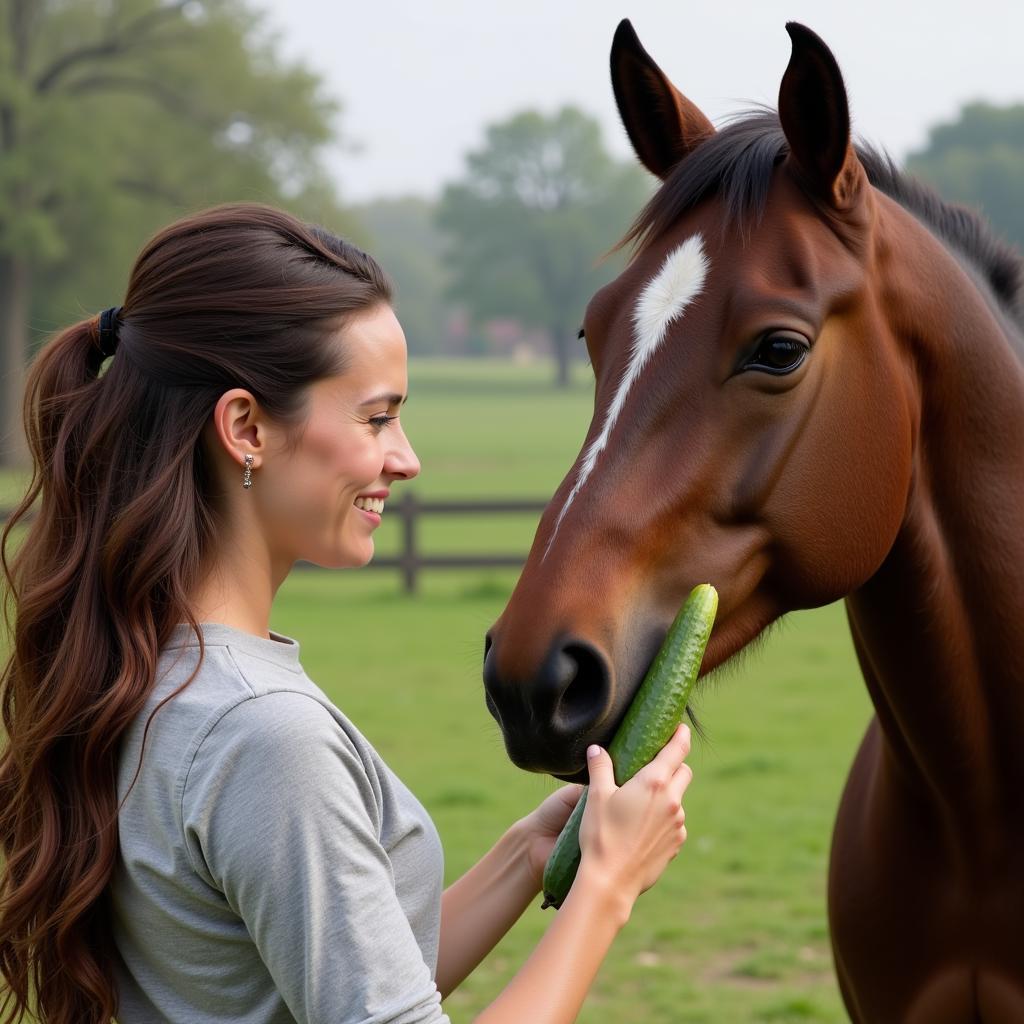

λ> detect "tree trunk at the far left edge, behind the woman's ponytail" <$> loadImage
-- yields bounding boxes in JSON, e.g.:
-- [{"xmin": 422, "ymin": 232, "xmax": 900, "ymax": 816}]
[{"xmin": 0, "ymin": 255, "xmax": 32, "ymax": 469}]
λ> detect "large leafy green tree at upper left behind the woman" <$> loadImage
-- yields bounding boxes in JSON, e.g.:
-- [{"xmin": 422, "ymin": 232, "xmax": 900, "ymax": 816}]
[{"xmin": 0, "ymin": 0, "xmax": 360, "ymax": 464}]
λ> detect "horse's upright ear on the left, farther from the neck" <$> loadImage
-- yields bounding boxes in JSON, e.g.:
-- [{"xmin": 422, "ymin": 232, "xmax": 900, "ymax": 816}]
[{"xmin": 611, "ymin": 18, "xmax": 715, "ymax": 178}]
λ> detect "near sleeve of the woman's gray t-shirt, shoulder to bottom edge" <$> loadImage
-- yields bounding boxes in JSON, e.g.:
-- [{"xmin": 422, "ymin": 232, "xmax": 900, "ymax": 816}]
[{"xmin": 181, "ymin": 692, "xmax": 449, "ymax": 1024}]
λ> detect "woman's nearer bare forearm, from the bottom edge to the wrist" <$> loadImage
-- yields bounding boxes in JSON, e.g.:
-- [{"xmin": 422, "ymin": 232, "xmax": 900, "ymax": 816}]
[{"xmin": 474, "ymin": 865, "xmax": 633, "ymax": 1024}]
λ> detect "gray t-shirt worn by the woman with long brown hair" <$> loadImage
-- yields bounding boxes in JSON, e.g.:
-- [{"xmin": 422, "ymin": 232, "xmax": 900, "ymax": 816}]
[{"xmin": 110, "ymin": 623, "xmax": 449, "ymax": 1024}]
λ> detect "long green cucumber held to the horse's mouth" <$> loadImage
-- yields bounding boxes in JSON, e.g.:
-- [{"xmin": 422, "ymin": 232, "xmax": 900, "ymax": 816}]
[{"xmin": 542, "ymin": 583, "xmax": 718, "ymax": 909}]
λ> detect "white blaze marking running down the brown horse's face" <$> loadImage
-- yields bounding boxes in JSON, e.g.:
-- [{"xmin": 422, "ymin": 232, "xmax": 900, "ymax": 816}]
[{"xmin": 541, "ymin": 233, "xmax": 709, "ymax": 561}]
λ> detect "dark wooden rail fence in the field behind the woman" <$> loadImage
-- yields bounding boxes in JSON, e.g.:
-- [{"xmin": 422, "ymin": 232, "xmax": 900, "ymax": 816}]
[{"xmin": 0, "ymin": 490, "xmax": 548, "ymax": 594}]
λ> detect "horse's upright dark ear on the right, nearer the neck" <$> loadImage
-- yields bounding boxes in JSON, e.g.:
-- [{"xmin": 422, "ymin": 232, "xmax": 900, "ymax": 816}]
[{"xmin": 778, "ymin": 22, "xmax": 862, "ymax": 209}]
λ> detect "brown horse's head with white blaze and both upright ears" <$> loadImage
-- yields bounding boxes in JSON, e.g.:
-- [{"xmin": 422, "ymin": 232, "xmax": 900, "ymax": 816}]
[{"xmin": 484, "ymin": 22, "xmax": 912, "ymax": 781}]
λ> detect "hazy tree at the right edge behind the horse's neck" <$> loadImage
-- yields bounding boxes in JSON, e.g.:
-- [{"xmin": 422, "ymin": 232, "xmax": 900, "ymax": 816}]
[{"xmin": 907, "ymin": 102, "xmax": 1024, "ymax": 250}]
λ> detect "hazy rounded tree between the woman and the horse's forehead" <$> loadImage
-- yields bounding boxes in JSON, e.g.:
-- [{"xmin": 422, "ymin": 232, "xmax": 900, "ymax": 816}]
[{"xmin": 438, "ymin": 106, "xmax": 653, "ymax": 386}]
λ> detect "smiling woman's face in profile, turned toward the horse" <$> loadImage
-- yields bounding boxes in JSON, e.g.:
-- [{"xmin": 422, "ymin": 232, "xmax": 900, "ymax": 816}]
[{"xmin": 258, "ymin": 305, "xmax": 420, "ymax": 568}]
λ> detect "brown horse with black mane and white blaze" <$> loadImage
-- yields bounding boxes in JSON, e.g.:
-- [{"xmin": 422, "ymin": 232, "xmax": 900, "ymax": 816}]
[{"xmin": 484, "ymin": 22, "xmax": 1024, "ymax": 1024}]
